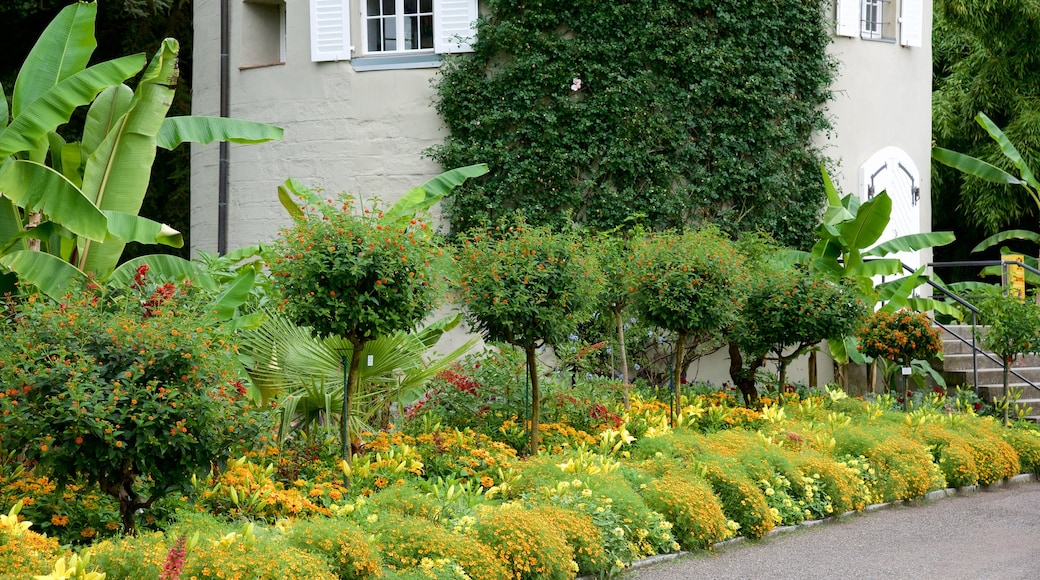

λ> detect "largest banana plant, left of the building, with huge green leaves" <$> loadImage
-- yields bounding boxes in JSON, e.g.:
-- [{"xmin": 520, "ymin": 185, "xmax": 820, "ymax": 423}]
[{"xmin": 0, "ymin": 2, "xmax": 282, "ymax": 296}]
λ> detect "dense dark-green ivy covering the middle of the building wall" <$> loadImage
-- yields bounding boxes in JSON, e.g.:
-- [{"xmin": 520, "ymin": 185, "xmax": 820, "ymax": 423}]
[{"xmin": 430, "ymin": 0, "xmax": 835, "ymax": 246}]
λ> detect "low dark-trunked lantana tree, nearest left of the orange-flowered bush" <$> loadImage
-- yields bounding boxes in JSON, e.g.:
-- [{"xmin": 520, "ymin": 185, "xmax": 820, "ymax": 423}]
[{"xmin": 729, "ymin": 266, "xmax": 866, "ymax": 393}]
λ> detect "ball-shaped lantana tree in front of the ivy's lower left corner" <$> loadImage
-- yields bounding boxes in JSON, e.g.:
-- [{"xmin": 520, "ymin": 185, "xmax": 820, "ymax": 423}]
[{"xmin": 457, "ymin": 219, "xmax": 600, "ymax": 455}]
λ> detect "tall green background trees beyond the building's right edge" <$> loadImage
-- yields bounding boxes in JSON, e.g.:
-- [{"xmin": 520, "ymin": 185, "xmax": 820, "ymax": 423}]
[{"xmin": 932, "ymin": 0, "xmax": 1040, "ymax": 278}]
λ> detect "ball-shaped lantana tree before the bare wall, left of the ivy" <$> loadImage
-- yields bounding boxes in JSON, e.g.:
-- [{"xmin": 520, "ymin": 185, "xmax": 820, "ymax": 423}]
[{"xmin": 270, "ymin": 195, "xmax": 443, "ymax": 459}]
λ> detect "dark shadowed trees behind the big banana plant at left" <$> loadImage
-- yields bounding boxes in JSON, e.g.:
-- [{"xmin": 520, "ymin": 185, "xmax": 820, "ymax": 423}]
[{"xmin": 0, "ymin": 0, "xmax": 192, "ymax": 260}]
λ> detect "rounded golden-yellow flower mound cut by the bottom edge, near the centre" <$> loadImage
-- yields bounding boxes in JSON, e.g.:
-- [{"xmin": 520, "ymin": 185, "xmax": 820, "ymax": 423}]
[{"xmin": 475, "ymin": 505, "xmax": 578, "ymax": 580}]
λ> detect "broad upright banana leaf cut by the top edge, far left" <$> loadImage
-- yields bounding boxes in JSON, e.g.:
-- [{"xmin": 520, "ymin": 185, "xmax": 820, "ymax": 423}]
[{"xmin": 11, "ymin": 2, "xmax": 98, "ymax": 116}]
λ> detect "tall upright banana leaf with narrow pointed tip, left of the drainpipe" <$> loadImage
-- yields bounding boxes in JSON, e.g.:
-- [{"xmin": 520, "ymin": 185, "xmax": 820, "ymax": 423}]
[{"xmin": 79, "ymin": 38, "xmax": 178, "ymax": 278}]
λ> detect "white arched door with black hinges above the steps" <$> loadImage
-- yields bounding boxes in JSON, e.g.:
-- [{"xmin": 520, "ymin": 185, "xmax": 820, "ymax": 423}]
[{"xmin": 859, "ymin": 147, "xmax": 921, "ymax": 268}]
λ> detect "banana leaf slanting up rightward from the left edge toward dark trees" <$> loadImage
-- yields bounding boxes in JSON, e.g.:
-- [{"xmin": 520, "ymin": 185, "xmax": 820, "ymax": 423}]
[{"xmin": 0, "ymin": 54, "xmax": 145, "ymax": 158}]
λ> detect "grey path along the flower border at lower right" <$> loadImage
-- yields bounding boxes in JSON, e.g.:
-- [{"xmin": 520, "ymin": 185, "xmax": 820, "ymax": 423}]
[{"xmin": 624, "ymin": 482, "xmax": 1040, "ymax": 580}]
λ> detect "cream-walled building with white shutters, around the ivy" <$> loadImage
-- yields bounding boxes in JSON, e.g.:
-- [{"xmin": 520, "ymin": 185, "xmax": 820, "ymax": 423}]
[{"xmin": 191, "ymin": 0, "xmax": 932, "ymax": 390}]
